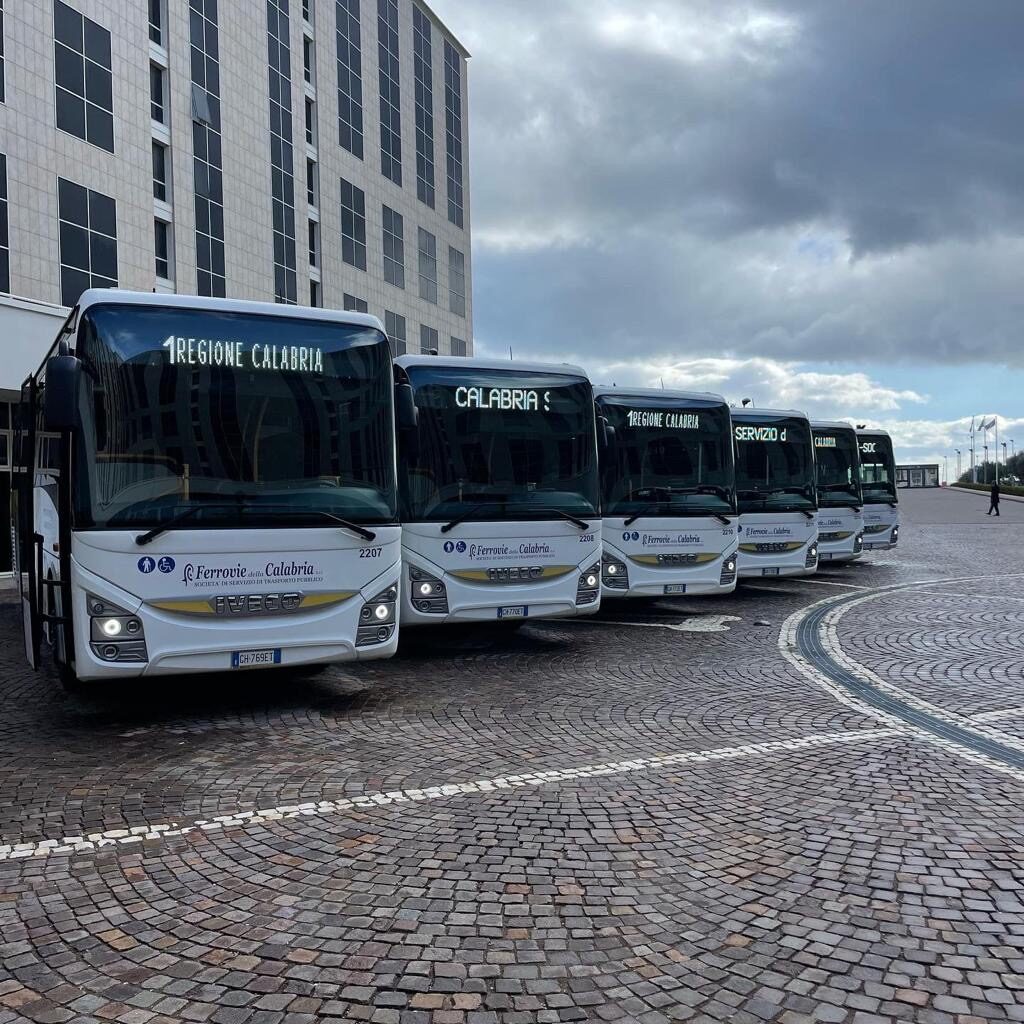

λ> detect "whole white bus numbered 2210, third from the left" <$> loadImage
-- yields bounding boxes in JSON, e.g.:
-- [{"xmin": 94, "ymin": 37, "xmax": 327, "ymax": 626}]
[{"xmin": 594, "ymin": 387, "xmax": 737, "ymax": 597}]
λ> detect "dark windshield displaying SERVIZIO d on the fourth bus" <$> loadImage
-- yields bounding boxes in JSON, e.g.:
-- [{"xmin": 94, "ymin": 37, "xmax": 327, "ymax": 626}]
[{"xmin": 733, "ymin": 415, "xmax": 817, "ymax": 512}]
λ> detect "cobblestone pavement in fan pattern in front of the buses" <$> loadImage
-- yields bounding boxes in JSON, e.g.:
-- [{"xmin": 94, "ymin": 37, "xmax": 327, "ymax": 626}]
[{"xmin": 0, "ymin": 492, "xmax": 1024, "ymax": 1024}]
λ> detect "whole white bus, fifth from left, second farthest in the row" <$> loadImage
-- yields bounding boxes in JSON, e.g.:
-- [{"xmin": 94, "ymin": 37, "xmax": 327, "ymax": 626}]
[{"xmin": 811, "ymin": 420, "xmax": 864, "ymax": 562}]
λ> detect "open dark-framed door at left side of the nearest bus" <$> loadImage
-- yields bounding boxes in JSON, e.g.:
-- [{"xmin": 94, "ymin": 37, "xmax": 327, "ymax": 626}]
[{"xmin": 10, "ymin": 378, "xmax": 43, "ymax": 669}]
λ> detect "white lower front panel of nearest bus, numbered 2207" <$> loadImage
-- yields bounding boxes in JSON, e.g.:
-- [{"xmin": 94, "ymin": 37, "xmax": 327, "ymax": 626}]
[{"xmin": 71, "ymin": 526, "xmax": 401, "ymax": 680}]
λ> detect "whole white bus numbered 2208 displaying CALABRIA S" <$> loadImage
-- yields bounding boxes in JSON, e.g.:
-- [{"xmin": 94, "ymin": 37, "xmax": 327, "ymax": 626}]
[{"xmin": 395, "ymin": 355, "xmax": 601, "ymax": 625}]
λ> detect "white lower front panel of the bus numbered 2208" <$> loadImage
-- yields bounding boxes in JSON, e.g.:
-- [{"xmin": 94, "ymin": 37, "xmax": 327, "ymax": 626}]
[{"xmin": 401, "ymin": 519, "xmax": 601, "ymax": 626}]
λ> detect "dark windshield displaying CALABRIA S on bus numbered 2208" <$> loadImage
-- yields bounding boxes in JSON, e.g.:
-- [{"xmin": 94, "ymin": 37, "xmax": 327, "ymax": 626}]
[{"xmin": 400, "ymin": 366, "xmax": 599, "ymax": 522}]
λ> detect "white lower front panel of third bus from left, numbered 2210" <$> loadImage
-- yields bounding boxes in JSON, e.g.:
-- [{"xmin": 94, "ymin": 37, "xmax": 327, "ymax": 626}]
[{"xmin": 601, "ymin": 516, "xmax": 736, "ymax": 598}]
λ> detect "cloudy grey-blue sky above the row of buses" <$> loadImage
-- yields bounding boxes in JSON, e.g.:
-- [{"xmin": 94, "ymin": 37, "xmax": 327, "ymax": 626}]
[{"xmin": 433, "ymin": 0, "xmax": 1024, "ymax": 471}]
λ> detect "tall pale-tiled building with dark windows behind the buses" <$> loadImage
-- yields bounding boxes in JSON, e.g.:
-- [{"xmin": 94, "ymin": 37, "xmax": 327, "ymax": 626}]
[{"xmin": 0, "ymin": 0, "xmax": 472, "ymax": 570}]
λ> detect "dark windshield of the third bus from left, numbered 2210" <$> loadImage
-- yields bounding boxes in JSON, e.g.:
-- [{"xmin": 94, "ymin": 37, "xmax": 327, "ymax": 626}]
[{"xmin": 597, "ymin": 394, "xmax": 736, "ymax": 517}]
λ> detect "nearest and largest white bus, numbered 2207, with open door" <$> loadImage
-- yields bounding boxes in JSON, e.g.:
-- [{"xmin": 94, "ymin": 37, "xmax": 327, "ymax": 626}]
[{"xmin": 14, "ymin": 290, "xmax": 400, "ymax": 686}]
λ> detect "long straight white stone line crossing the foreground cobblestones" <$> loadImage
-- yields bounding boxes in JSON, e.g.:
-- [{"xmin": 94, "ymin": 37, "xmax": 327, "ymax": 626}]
[{"xmin": 0, "ymin": 728, "xmax": 905, "ymax": 860}]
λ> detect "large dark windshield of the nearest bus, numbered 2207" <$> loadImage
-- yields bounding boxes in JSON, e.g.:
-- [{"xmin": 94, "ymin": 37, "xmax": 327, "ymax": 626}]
[{"xmin": 73, "ymin": 304, "xmax": 397, "ymax": 528}]
